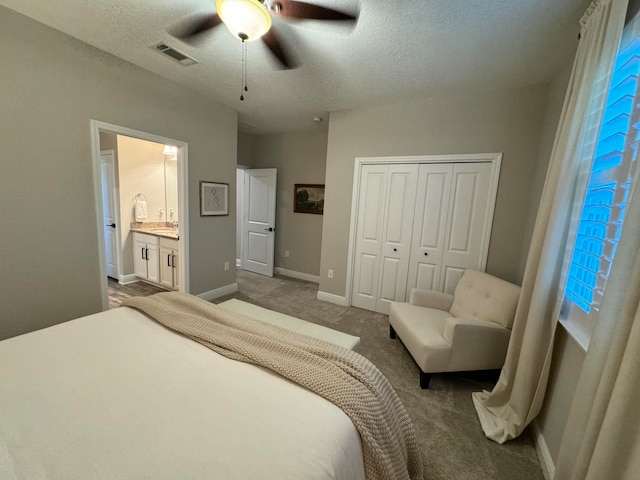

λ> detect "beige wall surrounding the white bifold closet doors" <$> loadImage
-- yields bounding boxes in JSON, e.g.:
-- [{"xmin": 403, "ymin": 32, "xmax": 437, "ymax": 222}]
[{"xmin": 320, "ymin": 86, "xmax": 547, "ymax": 296}]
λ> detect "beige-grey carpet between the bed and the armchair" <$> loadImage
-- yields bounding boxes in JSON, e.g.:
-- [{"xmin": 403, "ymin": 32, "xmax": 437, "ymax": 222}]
[{"xmin": 215, "ymin": 271, "xmax": 544, "ymax": 480}]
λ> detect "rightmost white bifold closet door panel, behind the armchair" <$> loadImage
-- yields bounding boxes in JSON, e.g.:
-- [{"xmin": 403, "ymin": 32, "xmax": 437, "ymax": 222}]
[{"xmin": 438, "ymin": 163, "xmax": 493, "ymax": 293}]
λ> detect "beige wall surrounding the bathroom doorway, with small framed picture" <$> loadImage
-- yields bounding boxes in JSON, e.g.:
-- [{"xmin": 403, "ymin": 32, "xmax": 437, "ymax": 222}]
[{"xmin": 0, "ymin": 7, "xmax": 237, "ymax": 339}]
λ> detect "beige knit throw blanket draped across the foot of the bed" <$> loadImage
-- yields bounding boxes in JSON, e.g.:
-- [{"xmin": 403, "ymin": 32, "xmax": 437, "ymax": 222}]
[{"xmin": 123, "ymin": 292, "xmax": 423, "ymax": 480}]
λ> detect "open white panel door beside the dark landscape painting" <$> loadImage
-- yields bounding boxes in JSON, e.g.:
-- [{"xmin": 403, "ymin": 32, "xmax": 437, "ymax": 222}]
[{"xmin": 242, "ymin": 168, "xmax": 277, "ymax": 277}]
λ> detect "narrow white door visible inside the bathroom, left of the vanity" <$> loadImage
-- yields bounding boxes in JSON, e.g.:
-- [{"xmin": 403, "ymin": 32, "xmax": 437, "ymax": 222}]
[{"xmin": 100, "ymin": 151, "xmax": 119, "ymax": 279}]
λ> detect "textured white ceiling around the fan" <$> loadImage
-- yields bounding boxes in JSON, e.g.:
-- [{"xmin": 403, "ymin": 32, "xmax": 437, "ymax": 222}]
[{"xmin": 0, "ymin": 0, "xmax": 589, "ymax": 134}]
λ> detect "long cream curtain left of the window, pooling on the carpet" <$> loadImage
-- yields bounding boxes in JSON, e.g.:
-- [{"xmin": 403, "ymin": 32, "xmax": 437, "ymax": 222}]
[{"xmin": 473, "ymin": 0, "xmax": 628, "ymax": 443}]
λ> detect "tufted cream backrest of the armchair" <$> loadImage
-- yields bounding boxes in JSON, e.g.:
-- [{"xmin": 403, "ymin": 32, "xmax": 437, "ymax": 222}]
[{"xmin": 449, "ymin": 270, "xmax": 520, "ymax": 328}]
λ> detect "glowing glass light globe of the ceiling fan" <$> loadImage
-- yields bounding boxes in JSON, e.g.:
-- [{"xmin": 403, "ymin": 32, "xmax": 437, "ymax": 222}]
[{"xmin": 216, "ymin": 0, "xmax": 271, "ymax": 42}]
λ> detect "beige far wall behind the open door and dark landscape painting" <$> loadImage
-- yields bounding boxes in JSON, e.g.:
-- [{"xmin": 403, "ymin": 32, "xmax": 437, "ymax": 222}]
[{"xmin": 253, "ymin": 129, "xmax": 327, "ymax": 276}]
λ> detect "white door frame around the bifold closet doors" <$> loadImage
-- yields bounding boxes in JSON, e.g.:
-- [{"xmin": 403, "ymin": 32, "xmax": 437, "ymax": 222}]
[{"xmin": 345, "ymin": 152, "xmax": 502, "ymax": 306}]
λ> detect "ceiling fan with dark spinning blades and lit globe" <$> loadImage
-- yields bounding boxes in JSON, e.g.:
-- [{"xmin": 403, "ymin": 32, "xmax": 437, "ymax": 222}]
[{"xmin": 170, "ymin": 0, "xmax": 358, "ymax": 69}]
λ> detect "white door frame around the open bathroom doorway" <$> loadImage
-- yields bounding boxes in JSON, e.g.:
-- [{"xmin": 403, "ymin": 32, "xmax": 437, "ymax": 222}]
[{"xmin": 89, "ymin": 119, "xmax": 190, "ymax": 310}]
